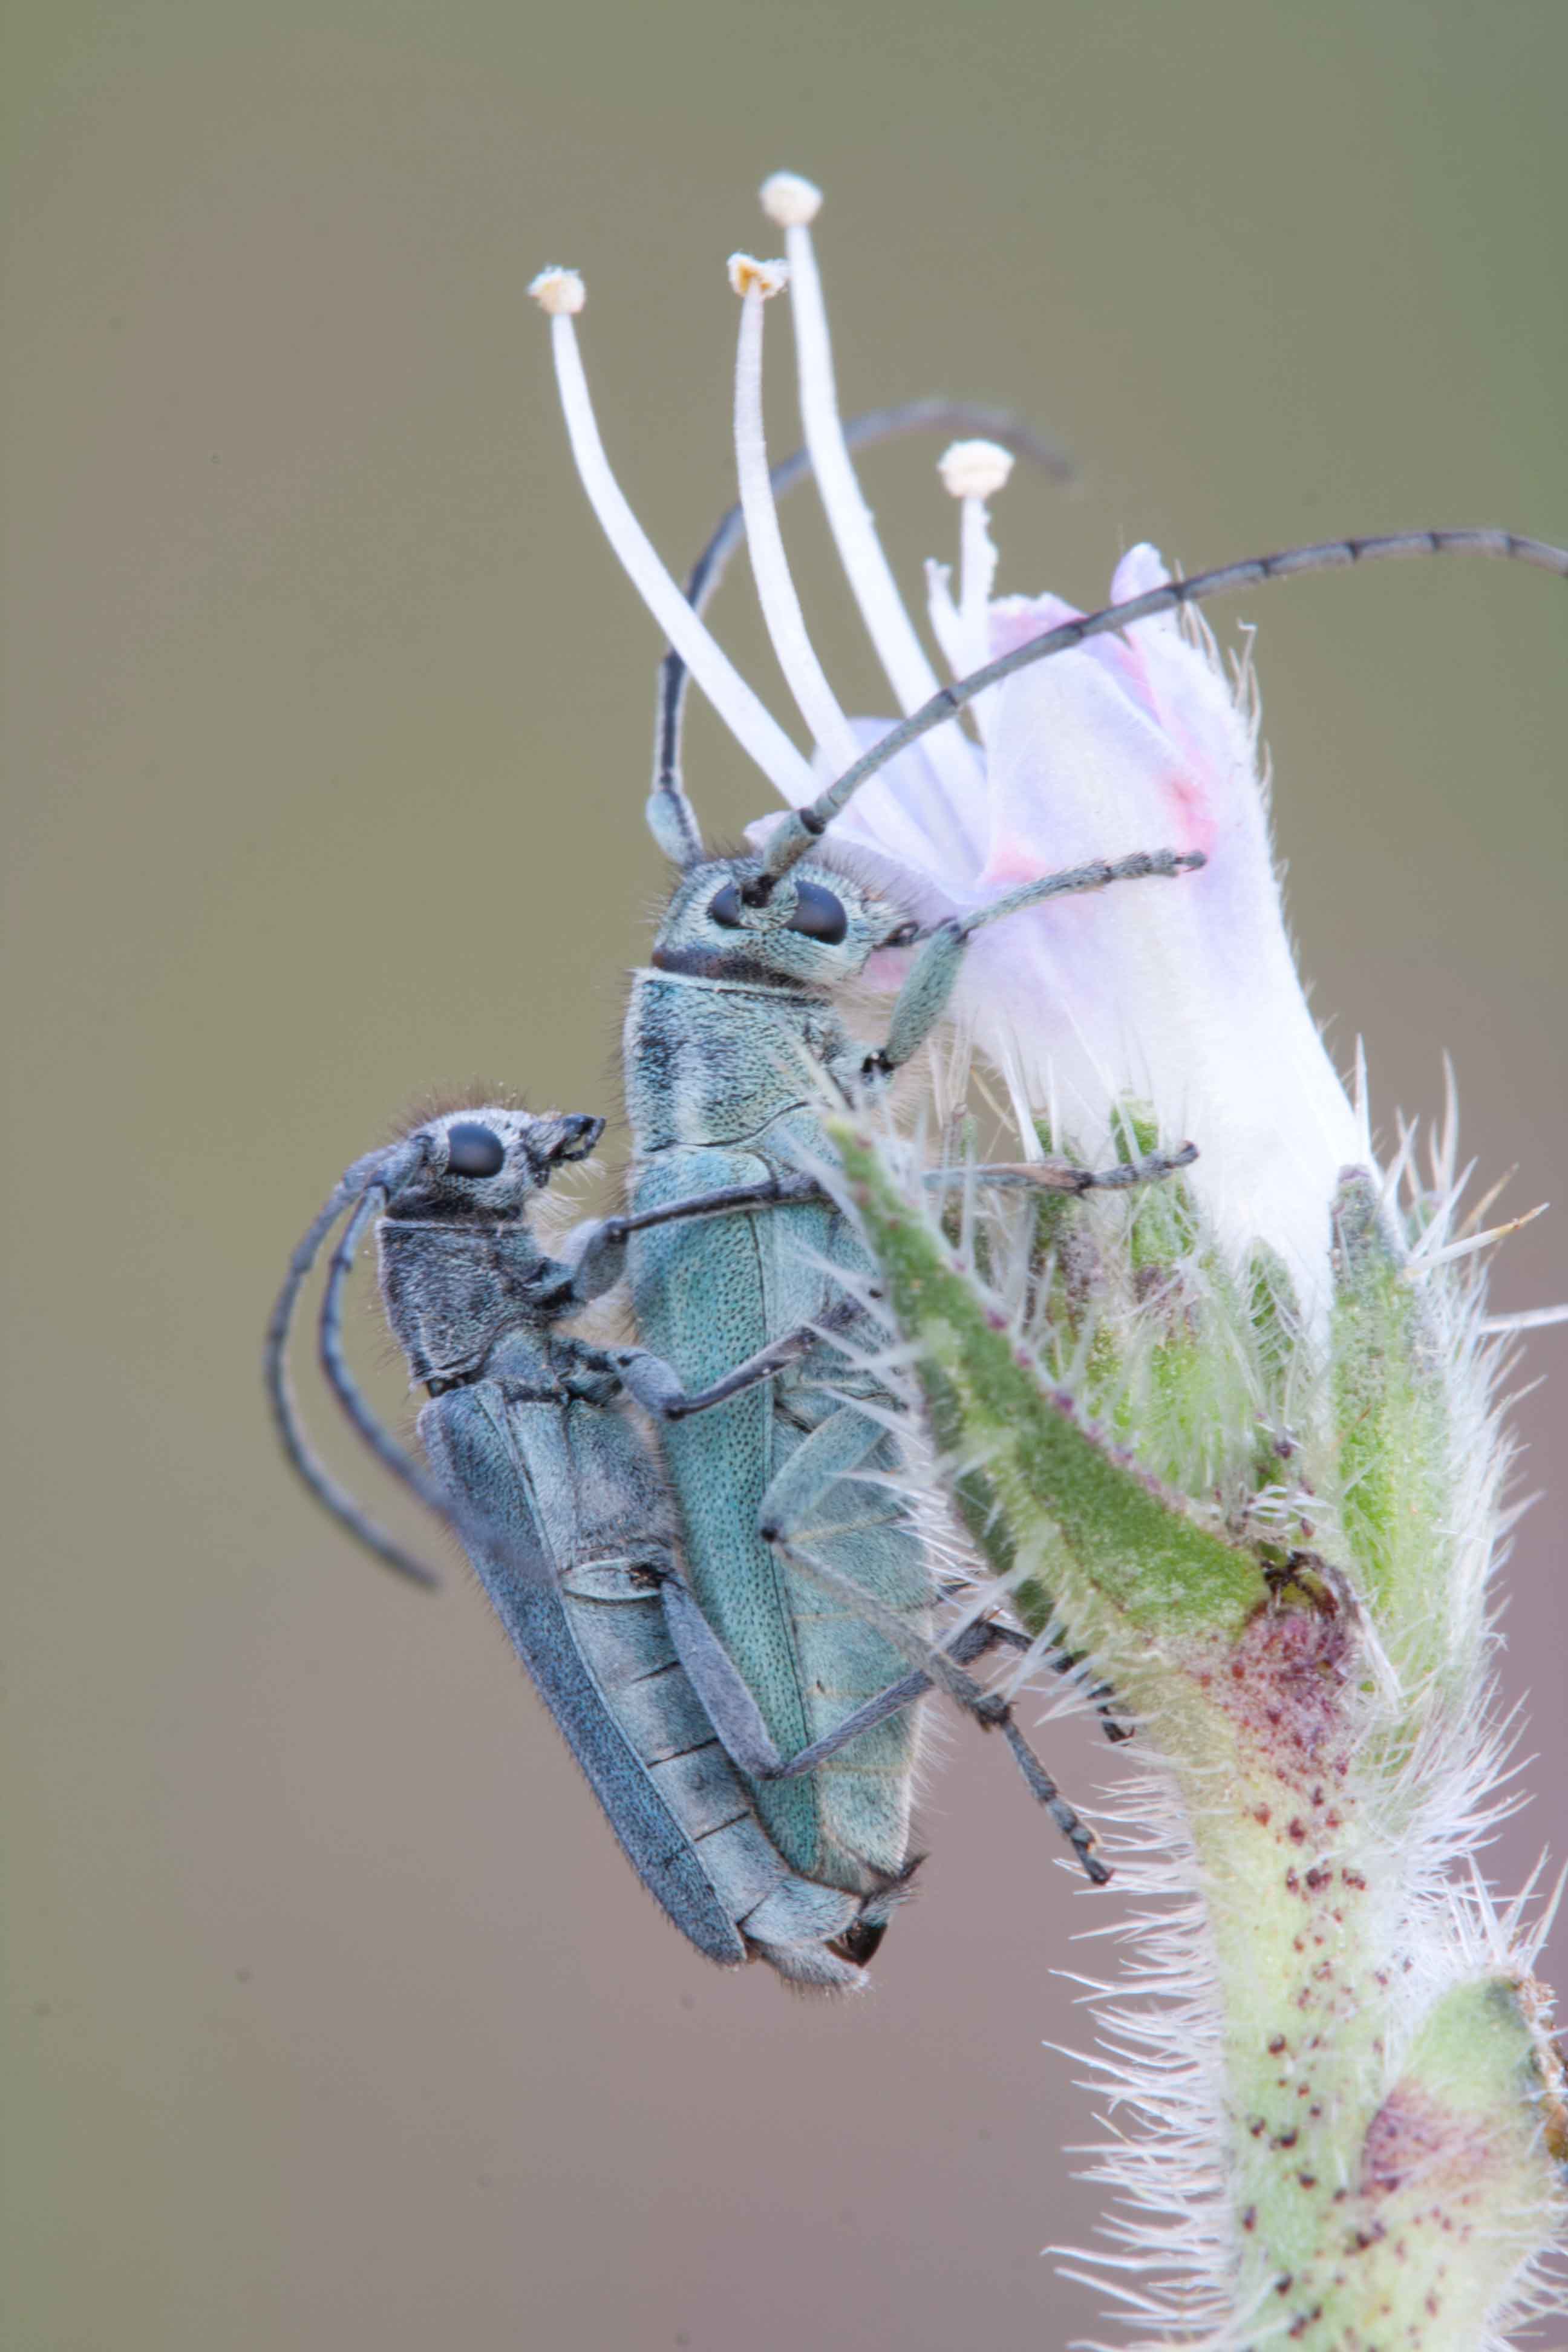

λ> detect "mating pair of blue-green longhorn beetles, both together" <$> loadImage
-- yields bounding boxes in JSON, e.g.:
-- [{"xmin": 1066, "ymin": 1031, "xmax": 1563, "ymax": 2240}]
[{"xmin": 268, "ymin": 402, "xmax": 1199, "ymax": 1985}]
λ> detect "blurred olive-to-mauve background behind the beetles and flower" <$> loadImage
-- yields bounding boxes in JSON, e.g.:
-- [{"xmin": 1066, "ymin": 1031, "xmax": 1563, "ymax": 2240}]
[{"xmin": 2, "ymin": 0, "xmax": 1568, "ymax": 2352}]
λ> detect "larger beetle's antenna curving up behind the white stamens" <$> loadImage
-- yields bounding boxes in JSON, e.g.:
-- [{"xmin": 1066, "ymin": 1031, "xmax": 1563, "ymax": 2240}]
[{"xmin": 649, "ymin": 397, "xmax": 1077, "ymax": 866}]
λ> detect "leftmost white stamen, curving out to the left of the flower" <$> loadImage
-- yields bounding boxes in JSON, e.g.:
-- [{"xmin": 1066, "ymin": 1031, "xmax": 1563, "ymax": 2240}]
[{"xmin": 529, "ymin": 270, "xmax": 815, "ymax": 807}]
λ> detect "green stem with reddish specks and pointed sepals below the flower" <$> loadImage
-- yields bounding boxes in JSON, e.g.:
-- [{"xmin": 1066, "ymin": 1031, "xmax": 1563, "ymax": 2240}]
[{"xmin": 837, "ymin": 1126, "xmax": 1568, "ymax": 2352}]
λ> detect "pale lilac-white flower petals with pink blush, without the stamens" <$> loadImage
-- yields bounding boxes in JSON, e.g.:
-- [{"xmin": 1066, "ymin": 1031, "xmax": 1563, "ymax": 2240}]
[{"xmin": 818, "ymin": 546, "xmax": 1366, "ymax": 1322}]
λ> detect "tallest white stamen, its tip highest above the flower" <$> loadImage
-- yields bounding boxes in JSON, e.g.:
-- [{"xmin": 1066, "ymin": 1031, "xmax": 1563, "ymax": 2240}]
[{"xmin": 762, "ymin": 172, "xmax": 973, "ymax": 792}]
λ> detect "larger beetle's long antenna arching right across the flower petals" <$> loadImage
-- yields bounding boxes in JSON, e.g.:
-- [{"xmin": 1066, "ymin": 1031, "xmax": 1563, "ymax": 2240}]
[{"xmin": 750, "ymin": 532, "xmax": 1568, "ymax": 901}]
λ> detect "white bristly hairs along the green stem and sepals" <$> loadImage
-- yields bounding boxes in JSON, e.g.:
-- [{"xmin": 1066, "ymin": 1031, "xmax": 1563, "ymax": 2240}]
[{"xmin": 823, "ymin": 1060, "xmax": 1566, "ymax": 2352}]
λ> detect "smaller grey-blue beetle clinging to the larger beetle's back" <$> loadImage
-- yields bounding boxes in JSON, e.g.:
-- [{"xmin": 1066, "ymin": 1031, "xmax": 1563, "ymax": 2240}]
[{"xmin": 268, "ymin": 1082, "xmax": 1184, "ymax": 1987}]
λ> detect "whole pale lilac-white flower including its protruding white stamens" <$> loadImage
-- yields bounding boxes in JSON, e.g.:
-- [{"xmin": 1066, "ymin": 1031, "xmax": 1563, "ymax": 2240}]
[{"xmin": 536, "ymin": 174, "xmax": 1366, "ymax": 1324}]
